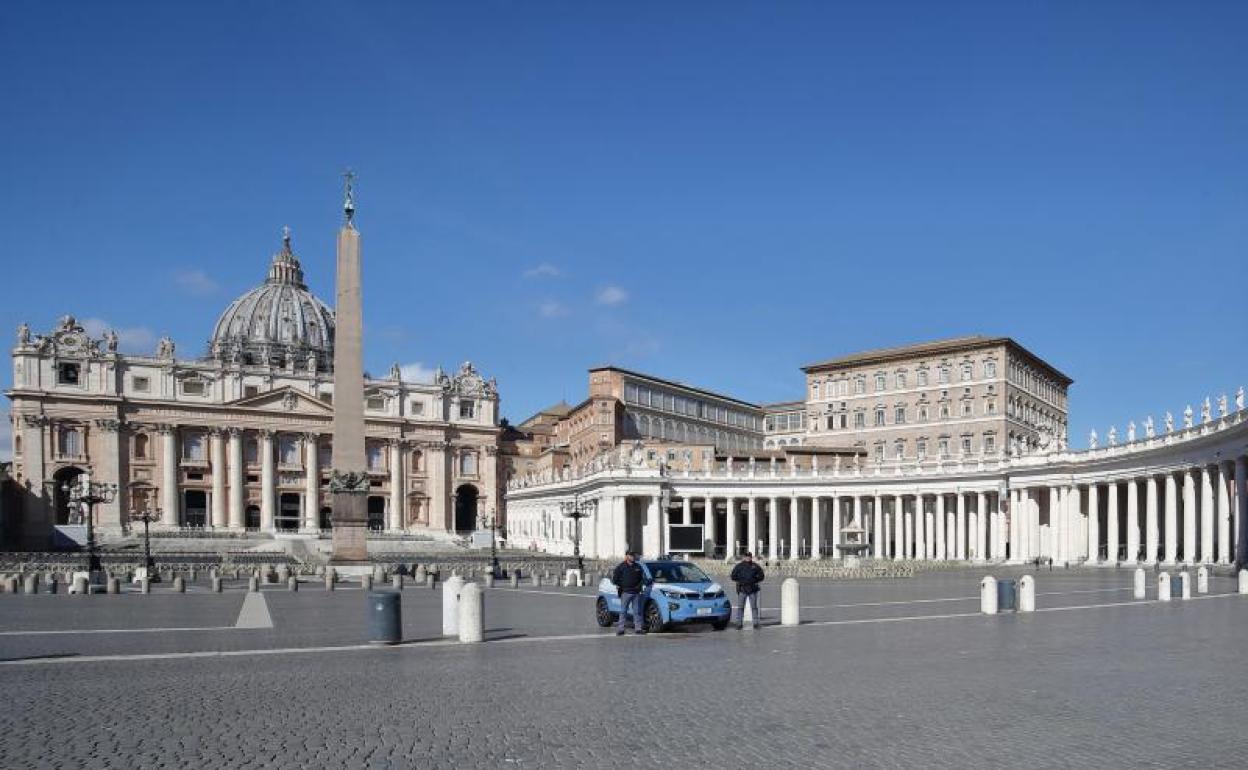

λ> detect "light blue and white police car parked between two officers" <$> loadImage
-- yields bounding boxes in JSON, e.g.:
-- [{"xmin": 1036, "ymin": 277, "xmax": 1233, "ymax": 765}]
[{"xmin": 594, "ymin": 559, "xmax": 733, "ymax": 633}]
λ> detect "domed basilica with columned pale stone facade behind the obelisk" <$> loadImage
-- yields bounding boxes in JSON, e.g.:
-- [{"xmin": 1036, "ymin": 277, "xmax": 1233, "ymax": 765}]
[{"xmin": 6, "ymin": 224, "xmax": 503, "ymax": 548}]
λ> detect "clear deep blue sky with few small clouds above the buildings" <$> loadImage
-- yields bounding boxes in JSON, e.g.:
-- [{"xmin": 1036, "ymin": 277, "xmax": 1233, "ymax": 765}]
[{"xmin": 0, "ymin": 1, "xmax": 1248, "ymax": 447}]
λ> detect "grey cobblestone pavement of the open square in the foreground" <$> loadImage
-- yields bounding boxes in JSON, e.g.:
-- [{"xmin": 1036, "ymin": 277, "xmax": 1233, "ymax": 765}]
[{"xmin": 0, "ymin": 570, "xmax": 1248, "ymax": 768}]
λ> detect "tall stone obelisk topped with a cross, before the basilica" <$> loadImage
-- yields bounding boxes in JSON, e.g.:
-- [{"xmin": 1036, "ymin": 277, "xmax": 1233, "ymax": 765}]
[{"xmin": 329, "ymin": 171, "xmax": 368, "ymax": 564}]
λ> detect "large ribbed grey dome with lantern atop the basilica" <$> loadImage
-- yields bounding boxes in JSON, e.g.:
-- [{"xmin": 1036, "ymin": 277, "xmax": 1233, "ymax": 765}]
[{"xmin": 208, "ymin": 230, "xmax": 333, "ymax": 371}]
